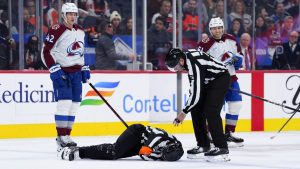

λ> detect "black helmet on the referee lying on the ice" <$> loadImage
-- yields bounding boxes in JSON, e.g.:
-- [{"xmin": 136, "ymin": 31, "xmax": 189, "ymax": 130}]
[{"xmin": 161, "ymin": 142, "xmax": 184, "ymax": 161}]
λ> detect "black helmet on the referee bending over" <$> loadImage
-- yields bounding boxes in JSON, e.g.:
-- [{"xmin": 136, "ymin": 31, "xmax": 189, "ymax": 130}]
[{"xmin": 165, "ymin": 48, "xmax": 185, "ymax": 72}]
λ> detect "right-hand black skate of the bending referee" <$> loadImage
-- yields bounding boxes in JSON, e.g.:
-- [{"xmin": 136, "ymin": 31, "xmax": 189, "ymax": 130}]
[{"xmin": 204, "ymin": 147, "xmax": 230, "ymax": 162}]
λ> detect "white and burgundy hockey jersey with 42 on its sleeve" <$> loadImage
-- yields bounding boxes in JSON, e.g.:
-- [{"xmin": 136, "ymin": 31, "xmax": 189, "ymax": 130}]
[{"xmin": 42, "ymin": 24, "xmax": 85, "ymax": 72}]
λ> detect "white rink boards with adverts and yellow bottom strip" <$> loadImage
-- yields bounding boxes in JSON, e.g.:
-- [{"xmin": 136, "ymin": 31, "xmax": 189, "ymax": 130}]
[{"xmin": 0, "ymin": 71, "xmax": 300, "ymax": 138}]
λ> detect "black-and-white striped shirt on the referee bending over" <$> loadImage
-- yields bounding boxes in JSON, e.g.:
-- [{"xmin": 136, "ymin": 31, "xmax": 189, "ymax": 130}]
[{"xmin": 183, "ymin": 49, "xmax": 228, "ymax": 113}]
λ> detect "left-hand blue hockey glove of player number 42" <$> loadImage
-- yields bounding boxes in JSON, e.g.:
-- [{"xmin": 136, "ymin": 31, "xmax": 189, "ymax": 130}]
[{"xmin": 49, "ymin": 64, "xmax": 66, "ymax": 86}]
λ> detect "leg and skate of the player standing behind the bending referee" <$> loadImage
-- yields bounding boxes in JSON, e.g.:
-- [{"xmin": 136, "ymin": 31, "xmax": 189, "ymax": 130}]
[{"xmin": 225, "ymin": 81, "xmax": 244, "ymax": 146}]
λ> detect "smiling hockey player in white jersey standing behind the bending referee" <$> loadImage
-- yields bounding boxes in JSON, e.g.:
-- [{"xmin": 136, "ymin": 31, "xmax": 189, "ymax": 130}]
[{"xmin": 187, "ymin": 17, "xmax": 244, "ymax": 158}]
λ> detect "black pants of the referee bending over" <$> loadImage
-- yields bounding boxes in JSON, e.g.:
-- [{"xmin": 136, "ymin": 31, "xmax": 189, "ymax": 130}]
[{"xmin": 191, "ymin": 72, "xmax": 230, "ymax": 148}]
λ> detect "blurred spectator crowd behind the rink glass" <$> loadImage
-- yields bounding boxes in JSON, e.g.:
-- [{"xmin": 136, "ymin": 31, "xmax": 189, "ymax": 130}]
[{"xmin": 0, "ymin": 0, "xmax": 300, "ymax": 70}]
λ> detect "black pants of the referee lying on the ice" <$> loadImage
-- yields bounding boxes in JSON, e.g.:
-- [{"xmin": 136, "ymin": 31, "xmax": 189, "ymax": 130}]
[{"xmin": 79, "ymin": 124, "xmax": 145, "ymax": 160}]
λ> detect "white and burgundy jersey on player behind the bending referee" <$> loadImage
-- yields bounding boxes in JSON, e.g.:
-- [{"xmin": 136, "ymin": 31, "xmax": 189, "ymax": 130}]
[{"xmin": 198, "ymin": 34, "xmax": 242, "ymax": 80}]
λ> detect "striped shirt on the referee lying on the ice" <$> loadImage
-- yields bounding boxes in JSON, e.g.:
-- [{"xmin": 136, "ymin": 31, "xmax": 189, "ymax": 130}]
[{"xmin": 140, "ymin": 126, "xmax": 181, "ymax": 161}]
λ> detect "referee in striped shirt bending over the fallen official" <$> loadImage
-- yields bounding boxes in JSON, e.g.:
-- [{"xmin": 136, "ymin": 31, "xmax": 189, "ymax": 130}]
[{"xmin": 165, "ymin": 48, "xmax": 233, "ymax": 161}]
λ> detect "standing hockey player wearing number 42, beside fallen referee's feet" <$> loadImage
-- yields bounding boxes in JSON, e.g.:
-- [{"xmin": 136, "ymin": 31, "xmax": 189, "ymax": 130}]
[{"xmin": 42, "ymin": 3, "xmax": 90, "ymax": 151}]
